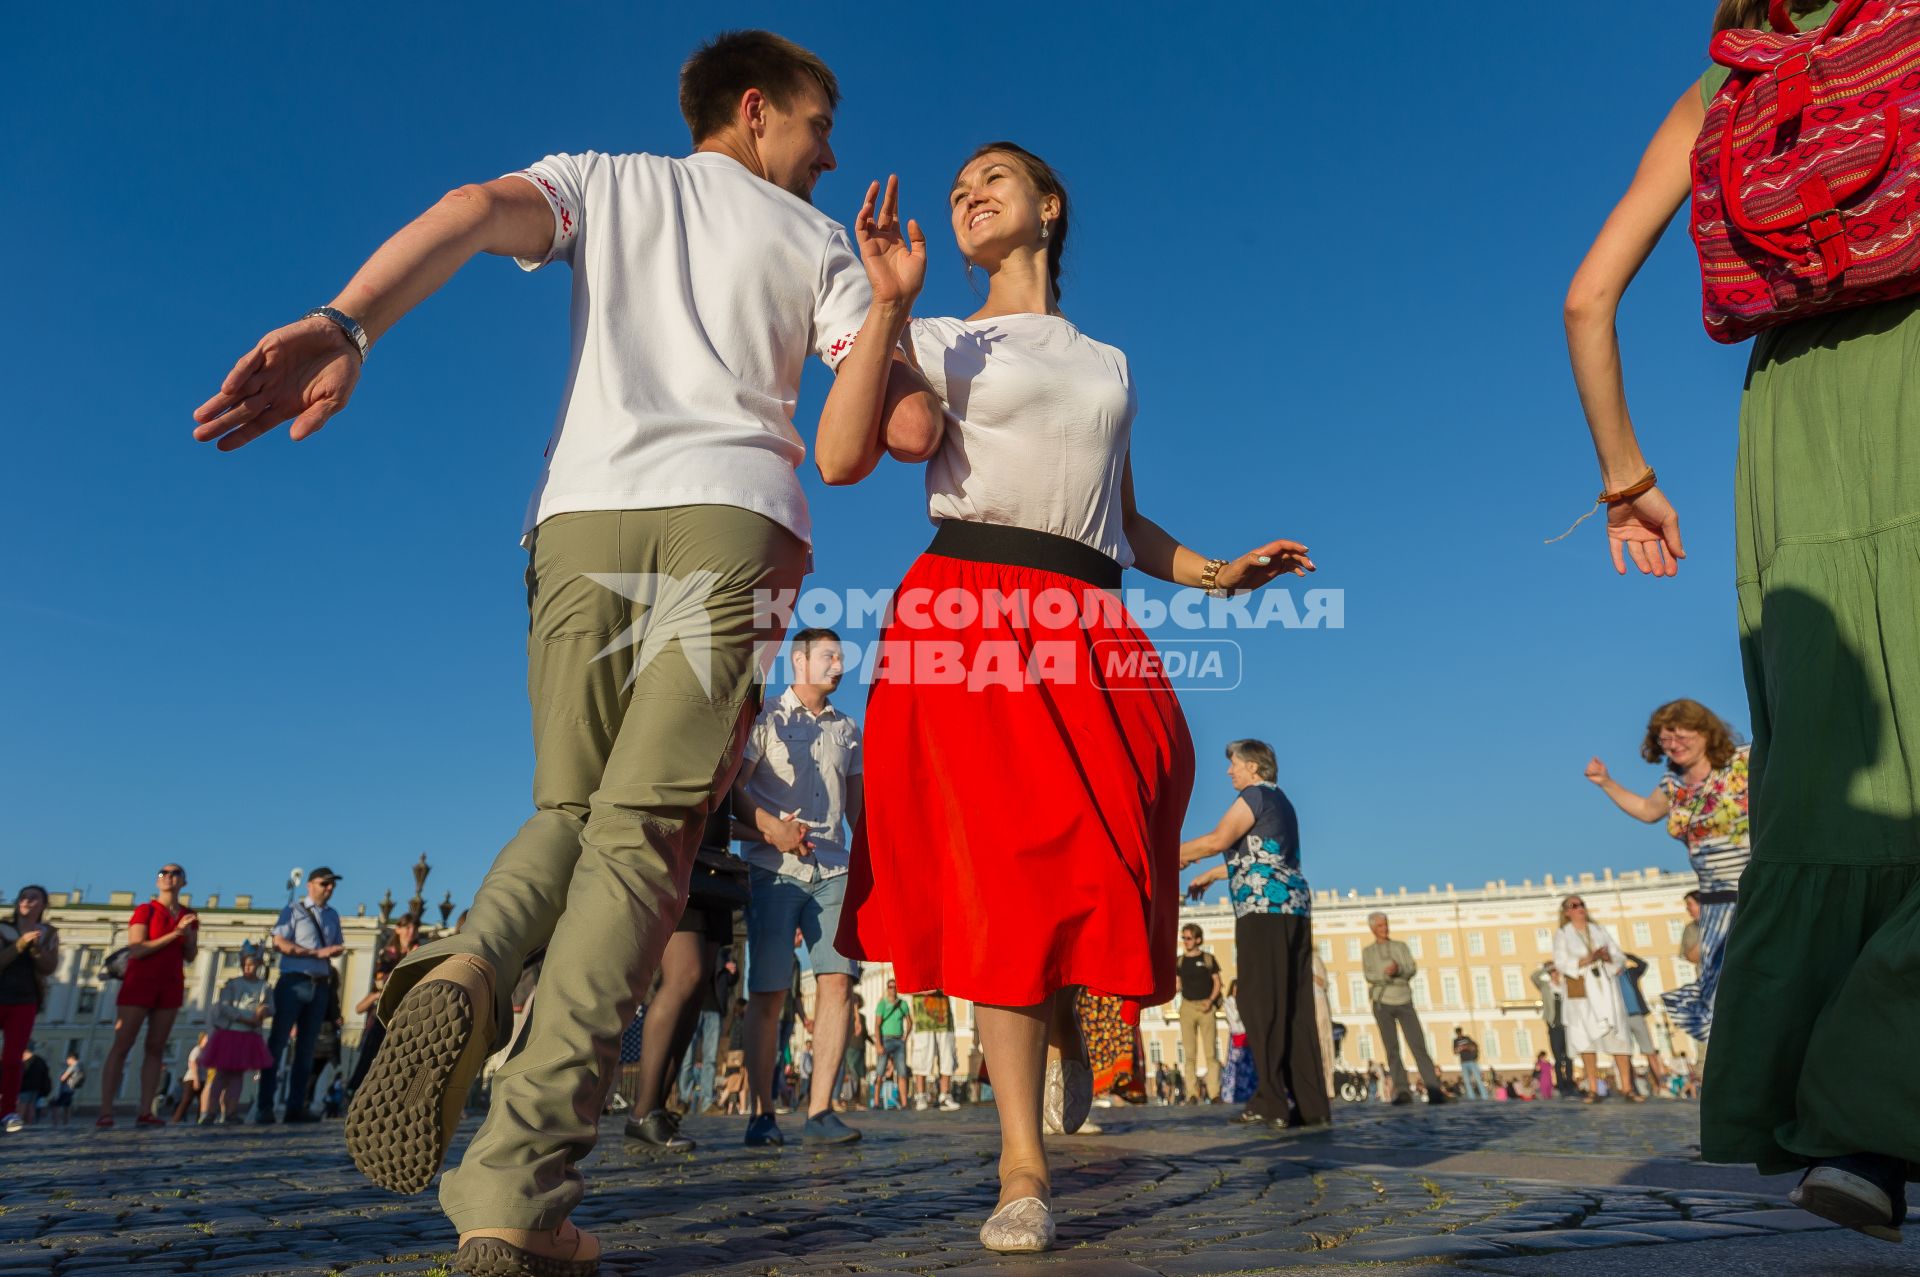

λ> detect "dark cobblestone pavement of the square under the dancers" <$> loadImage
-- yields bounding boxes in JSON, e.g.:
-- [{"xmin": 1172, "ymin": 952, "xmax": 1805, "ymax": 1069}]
[{"xmin": 0, "ymin": 1102, "xmax": 1920, "ymax": 1277}]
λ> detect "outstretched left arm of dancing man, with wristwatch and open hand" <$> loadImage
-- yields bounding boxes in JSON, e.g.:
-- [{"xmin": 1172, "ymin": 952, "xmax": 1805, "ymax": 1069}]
[{"xmin": 194, "ymin": 177, "xmax": 553, "ymax": 451}]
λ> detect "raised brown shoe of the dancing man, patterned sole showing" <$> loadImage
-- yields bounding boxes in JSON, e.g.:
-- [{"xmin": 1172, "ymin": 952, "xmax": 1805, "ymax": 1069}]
[{"xmin": 346, "ymin": 954, "xmax": 493, "ymax": 1193}]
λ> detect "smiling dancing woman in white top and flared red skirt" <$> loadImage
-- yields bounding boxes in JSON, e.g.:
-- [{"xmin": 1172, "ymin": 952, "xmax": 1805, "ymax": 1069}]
[{"xmin": 816, "ymin": 154, "xmax": 1313, "ymax": 1250}]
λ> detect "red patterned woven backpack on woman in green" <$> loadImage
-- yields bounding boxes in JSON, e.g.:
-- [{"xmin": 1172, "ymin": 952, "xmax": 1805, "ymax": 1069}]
[{"xmin": 1693, "ymin": 0, "xmax": 1920, "ymax": 342}]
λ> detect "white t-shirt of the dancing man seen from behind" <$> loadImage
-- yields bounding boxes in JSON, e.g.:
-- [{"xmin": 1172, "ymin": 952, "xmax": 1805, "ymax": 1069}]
[{"xmin": 515, "ymin": 152, "xmax": 870, "ymax": 542}]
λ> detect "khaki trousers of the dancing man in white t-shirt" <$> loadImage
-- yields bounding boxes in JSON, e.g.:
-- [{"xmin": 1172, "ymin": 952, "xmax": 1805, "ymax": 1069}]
[{"xmin": 380, "ymin": 505, "xmax": 808, "ymax": 1233}]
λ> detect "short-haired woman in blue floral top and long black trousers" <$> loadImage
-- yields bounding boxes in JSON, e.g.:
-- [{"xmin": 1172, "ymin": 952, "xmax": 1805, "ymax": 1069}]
[{"xmin": 1181, "ymin": 741, "xmax": 1332, "ymax": 1127}]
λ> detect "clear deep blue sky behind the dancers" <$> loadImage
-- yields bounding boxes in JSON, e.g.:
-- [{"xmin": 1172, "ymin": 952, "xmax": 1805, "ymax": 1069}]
[{"xmin": 0, "ymin": 0, "xmax": 1747, "ymax": 906}]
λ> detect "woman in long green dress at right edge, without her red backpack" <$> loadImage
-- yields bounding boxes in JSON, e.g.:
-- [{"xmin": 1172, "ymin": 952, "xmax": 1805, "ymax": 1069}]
[{"xmin": 1567, "ymin": 0, "xmax": 1920, "ymax": 1241}]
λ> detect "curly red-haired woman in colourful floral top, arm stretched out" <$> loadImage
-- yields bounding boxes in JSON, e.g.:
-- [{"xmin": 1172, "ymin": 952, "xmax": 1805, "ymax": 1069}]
[{"xmin": 1586, "ymin": 701, "xmax": 1753, "ymax": 1043}]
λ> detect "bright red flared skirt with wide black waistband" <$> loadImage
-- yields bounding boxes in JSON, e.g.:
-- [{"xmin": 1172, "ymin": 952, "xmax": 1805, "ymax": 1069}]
[{"xmin": 835, "ymin": 522, "xmax": 1194, "ymax": 1006}]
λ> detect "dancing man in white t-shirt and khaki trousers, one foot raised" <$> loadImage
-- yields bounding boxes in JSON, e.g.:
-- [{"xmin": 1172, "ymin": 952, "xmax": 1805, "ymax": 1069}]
[{"xmin": 194, "ymin": 31, "xmax": 939, "ymax": 1275}]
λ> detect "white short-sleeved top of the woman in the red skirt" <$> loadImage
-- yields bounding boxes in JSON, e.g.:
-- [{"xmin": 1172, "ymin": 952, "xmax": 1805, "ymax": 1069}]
[{"xmin": 910, "ymin": 315, "xmax": 1135, "ymax": 566}]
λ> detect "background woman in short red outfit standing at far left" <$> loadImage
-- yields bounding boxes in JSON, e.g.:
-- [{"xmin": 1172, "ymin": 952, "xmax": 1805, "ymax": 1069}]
[{"xmin": 94, "ymin": 864, "xmax": 200, "ymax": 1127}]
